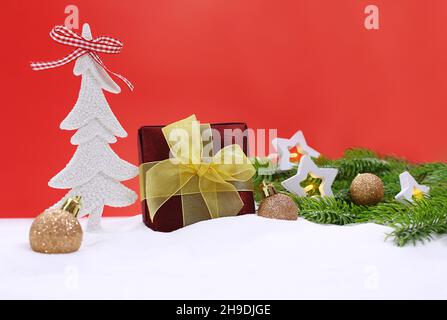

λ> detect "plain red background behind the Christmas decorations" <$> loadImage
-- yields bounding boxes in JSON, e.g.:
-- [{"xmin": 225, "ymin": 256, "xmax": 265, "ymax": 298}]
[{"xmin": 0, "ymin": 0, "xmax": 447, "ymax": 217}]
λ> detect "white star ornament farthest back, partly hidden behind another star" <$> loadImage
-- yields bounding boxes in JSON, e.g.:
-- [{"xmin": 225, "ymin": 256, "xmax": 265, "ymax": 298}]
[{"xmin": 272, "ymin": 131, "xmax": 320, "ymax": 171}]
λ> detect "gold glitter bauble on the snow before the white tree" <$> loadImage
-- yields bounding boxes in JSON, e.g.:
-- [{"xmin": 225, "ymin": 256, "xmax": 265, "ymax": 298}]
[{"xmin": 29, "ymin": 197, "xmax": 83, "ymax": 253}]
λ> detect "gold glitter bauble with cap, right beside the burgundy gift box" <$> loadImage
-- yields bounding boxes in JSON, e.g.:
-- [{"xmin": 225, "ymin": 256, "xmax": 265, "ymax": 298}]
[{"xmin": 258, "ymin": 183, "xmax": 299, "ymax": 220}]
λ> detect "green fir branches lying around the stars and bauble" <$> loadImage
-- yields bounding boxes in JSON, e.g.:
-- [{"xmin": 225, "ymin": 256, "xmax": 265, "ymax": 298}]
[{"xmin": 253, "ymin": 148, "xmax": 447, "ymax": 246}]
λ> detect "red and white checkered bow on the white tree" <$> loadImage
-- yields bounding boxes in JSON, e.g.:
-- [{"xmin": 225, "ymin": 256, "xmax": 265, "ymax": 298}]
[{"xmin": 31, "ymin": 26, "xmax": 134, "ymax": 90}]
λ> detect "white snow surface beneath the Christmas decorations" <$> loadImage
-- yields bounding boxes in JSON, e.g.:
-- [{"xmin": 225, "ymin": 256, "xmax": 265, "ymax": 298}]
[{"xmin": 0, "ymin": 215, "xmax": 447, "ymax": 299}]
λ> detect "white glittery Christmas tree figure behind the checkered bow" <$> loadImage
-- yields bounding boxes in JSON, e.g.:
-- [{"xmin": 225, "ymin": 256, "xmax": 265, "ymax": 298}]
[{"xmin": 48, "ymin": 24, "xmax": 138, "ymax": 231}]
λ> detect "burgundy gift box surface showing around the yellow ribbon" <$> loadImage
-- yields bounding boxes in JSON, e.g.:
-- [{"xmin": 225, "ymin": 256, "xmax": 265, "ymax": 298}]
[{"xmin": 138, "ymin": 123, "xmax": 255, "ymax": 232}]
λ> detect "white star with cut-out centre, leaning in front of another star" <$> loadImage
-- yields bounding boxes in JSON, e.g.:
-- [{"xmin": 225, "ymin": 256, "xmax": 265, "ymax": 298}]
[{"xmin": 281, "ymin": 155, "xmax": 338, "ymax": 197}]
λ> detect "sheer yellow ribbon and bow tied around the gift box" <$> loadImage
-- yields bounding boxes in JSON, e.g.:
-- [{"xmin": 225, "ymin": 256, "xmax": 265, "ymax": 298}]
[{"xmin": 145, "ymin": 116, "xmax": 255, "ymax": 225}]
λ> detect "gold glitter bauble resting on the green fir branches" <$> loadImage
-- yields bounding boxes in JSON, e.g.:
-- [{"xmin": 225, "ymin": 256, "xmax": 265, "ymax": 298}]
[{"xmin": 349, "ymin": 173, "xmax": 384, "ymax": 206}]
